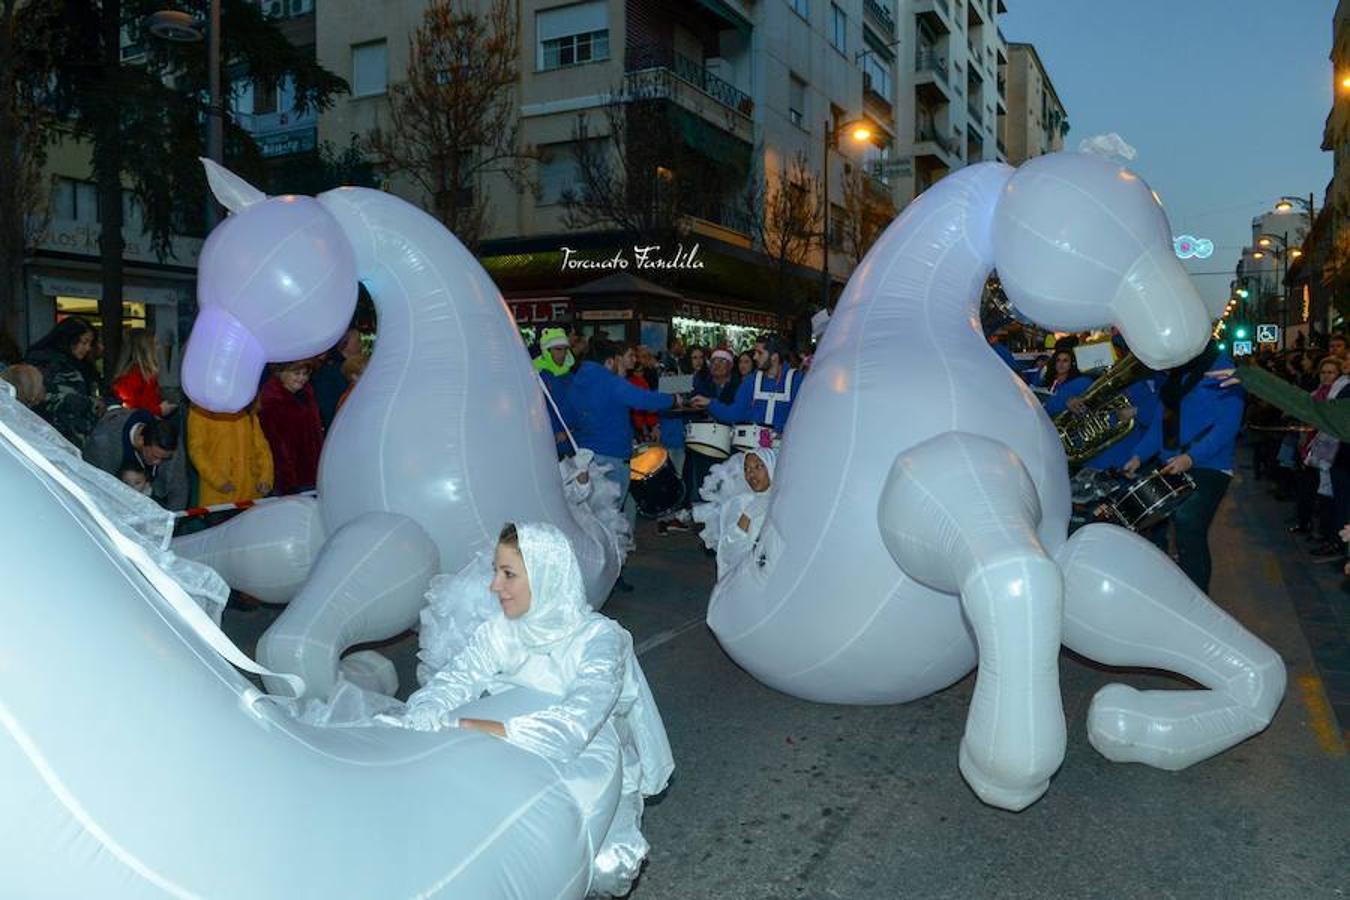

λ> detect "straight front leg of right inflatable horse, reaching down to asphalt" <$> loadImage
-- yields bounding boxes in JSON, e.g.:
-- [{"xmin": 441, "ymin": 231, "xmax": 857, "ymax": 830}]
[{"xmin": 878, "ymin": 432, "xmax": 1065, "ymax": 810}]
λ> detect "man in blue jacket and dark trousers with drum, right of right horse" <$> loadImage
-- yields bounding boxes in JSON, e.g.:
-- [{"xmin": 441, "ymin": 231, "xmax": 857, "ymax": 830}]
[{"xmin": 1122, "ymin": 341, "xmax": 1246, "ymax": 594}]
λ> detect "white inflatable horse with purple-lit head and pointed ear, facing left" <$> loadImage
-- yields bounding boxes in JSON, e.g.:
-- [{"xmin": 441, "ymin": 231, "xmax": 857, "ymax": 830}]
[{"xmin": 174, "ymin": 162, "xmax": 622, "ymax": 699}]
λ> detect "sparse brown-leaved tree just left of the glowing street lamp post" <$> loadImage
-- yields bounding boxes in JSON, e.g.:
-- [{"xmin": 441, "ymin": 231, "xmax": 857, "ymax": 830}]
[{"xmin": 741, "ymin": 151, "xmax": 825, "ymax": 314}]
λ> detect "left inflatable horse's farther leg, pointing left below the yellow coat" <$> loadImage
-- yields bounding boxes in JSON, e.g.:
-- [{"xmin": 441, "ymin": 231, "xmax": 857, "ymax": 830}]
[{"xmin": 171, "ymin": 497, "xmax": 324, "ymax": 603}]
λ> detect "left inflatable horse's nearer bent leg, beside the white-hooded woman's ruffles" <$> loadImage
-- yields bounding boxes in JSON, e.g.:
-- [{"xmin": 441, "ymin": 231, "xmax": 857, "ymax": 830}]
[{"xmin": 258, "ymin": 513, "xmax": 440, "ymax": 699}]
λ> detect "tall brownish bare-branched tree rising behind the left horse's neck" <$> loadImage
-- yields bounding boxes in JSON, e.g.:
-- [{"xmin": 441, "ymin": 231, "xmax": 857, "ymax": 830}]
[{"xmin": 365, "ymin": 0, "xmax": 533, "ymax": 250}]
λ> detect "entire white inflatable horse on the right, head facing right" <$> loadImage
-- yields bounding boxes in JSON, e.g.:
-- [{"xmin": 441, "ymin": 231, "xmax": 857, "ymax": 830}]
[{"xmin": 707, "ymin": 154, "xmax": 1284, "ymax": 810}]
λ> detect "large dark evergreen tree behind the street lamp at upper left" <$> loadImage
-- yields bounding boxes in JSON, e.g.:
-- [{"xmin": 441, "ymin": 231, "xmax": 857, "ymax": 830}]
[{"xmin": 35, "ymin": 0, "xmax": 347, "ymax": 375}]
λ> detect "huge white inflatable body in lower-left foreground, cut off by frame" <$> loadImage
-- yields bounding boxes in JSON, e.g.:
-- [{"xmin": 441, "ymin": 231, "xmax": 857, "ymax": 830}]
[{"xmin": 0, "ymin": 418, "xmax": 602, "ymax": 900}]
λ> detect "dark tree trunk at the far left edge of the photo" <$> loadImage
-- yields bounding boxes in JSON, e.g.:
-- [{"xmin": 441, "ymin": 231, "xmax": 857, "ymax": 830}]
[{"xmin": 0, "ymin": 0, "xmax": 57, "ymax": 348}]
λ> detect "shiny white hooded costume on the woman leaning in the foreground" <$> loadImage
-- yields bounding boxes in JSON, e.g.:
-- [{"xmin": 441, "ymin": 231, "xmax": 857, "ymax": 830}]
[{"xmin": 404, "ymin": 524, "xmax": 675, "ymax": 896}]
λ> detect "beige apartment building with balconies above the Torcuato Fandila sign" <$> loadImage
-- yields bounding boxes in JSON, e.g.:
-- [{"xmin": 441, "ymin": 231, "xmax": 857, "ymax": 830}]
[{"xmin": 316, "ymin": 0, "xmax": 907, "ymax": 337}]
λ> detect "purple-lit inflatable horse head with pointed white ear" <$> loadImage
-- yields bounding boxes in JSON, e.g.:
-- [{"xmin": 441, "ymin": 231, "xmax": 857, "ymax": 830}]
[{"xmin": 182, "ymin": 159, "xmax": 356, "ymax": 413}]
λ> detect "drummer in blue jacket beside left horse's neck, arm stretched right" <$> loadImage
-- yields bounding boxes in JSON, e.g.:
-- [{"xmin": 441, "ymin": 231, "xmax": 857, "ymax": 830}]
[{"xmin": 567, "ymin": 337, "xmax": 679, "ymax": 521}]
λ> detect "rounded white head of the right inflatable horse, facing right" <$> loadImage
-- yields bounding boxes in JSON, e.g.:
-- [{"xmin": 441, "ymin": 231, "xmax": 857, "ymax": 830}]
[{"xmin": 994, "ymin": 154, "xmax": 1211, "ymax": 370}]
